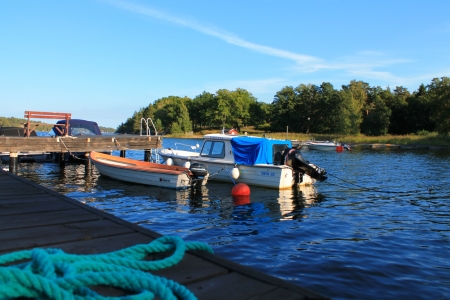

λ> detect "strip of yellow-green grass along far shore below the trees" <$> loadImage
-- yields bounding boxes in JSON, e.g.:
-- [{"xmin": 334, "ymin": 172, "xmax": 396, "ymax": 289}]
[{"xmin": 167, "ymin": 127, "xmax": 450, "ymax": 147}]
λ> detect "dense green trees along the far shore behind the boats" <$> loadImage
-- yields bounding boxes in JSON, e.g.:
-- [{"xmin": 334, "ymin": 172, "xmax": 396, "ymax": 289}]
[{"xmin": 117, "ymin": 77, "xmax": 450, "ymax": 136}]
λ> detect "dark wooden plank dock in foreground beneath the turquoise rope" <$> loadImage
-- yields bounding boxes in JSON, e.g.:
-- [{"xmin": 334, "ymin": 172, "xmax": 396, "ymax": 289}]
[{"xmin": 0, "ymin": 170, "xmax": 326, "ymax": 300}]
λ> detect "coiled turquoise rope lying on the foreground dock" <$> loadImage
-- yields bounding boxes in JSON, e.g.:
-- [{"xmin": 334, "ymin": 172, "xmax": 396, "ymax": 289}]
[{"xmin": 0, "ymin": 236, "xmax": 213, "ymax": 300}]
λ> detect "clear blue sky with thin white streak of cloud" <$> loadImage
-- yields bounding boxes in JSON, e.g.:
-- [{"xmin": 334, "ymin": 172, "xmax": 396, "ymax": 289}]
[{"xmin": 0, "ymin": 0, "xmax": 450, "ymax": 127}]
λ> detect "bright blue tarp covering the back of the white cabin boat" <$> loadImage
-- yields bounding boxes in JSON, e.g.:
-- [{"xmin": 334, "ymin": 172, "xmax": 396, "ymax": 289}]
[{"xmin": 231, "ymin": 137, "xmax": 292, "ymax": 165}]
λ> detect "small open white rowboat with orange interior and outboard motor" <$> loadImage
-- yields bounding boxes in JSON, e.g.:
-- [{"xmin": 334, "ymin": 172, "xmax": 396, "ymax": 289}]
[{"xmin": 90, "ymin": 151, "xmax": 209, "ymax": 189}]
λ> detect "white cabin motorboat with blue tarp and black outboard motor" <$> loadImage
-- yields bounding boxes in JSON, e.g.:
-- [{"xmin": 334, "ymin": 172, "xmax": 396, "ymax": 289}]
[{"xmin": 159, "ymin": 133, "xmax": 326, "ymax": 189}]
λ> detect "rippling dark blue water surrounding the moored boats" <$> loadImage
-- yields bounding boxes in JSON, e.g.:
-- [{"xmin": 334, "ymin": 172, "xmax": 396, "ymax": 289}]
[{"xmin": 2, "ymin": 139, "xmax": 450, "ymax": 299}]
